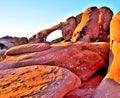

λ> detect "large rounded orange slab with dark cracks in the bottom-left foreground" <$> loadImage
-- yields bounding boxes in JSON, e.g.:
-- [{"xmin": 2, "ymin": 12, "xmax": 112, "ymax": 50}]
[{"xmin": 0, "ymin": 65, "xmax": 81, "ymax": 98}]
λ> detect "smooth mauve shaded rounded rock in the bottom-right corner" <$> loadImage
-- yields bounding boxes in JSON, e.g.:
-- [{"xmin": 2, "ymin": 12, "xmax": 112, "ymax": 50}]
[{"xmin": 92, "ymin": 78, "xmax": 120, "ymax": 98}]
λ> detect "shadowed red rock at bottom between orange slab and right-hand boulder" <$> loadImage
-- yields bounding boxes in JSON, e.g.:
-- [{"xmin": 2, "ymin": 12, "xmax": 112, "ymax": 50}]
[{"xmin": 64, "ymin": 75, "xmax": 104, "ymax": 98}]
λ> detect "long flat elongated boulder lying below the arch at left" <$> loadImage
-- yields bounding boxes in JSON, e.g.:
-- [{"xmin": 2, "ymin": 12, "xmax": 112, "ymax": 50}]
[{"xmin": 5, "ymin": 43, "xmax": 50, "ymax": 55}]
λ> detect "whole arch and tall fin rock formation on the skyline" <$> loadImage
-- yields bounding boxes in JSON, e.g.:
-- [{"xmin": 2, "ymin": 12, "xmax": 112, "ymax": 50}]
[{"xmin": 29, "ymin": 7, "xmax": 113, "ymax": 43}]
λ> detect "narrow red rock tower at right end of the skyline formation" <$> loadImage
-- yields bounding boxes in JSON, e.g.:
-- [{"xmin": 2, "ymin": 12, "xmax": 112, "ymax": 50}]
[{"xmin": 98, "ymin": 7, "xmax": 113, "ymax": 41}]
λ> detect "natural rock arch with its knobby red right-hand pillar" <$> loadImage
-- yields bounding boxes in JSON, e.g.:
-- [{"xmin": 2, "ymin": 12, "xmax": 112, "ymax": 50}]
[{"xmin": 29, "ymin": 17, "xmax": 76, "ymax": 43}]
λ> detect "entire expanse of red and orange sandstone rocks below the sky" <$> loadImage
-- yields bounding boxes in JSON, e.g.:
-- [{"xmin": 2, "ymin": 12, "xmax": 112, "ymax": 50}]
[{"xmin": 0, "ymin": 7, "xmax": 117, "ymax": 98}]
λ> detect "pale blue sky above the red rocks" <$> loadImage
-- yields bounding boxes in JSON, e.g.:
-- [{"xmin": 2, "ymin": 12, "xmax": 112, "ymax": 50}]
[{"xmin": 0, "ymin": 0, "xmax": 120, "ymax": 40}]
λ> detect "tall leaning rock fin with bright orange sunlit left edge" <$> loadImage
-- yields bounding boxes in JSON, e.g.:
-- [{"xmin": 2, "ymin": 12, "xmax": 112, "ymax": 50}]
[{"xmin": 71, "ymin": 7, "xmax": 99, "ymax": 42}]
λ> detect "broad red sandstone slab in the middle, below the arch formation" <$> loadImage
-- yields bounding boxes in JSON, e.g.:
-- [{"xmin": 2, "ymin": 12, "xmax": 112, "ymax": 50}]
[{"xmin": 0, "ymin": 43, "xmax": 109, "ymax": 81}]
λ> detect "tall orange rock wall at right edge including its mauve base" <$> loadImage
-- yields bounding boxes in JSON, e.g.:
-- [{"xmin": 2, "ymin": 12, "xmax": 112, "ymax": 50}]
[{"xmin": 93, "ymin": 12, "xmax": 120, "ymax": 98}]
